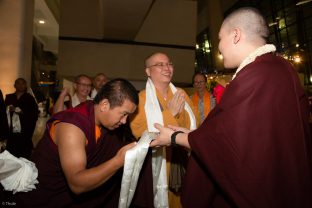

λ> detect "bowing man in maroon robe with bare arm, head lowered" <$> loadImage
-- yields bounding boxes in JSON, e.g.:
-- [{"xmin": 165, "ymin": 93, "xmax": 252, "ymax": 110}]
[{"xmin": 16, "ymin": 79, "xmax": 154, "ymax": 208}]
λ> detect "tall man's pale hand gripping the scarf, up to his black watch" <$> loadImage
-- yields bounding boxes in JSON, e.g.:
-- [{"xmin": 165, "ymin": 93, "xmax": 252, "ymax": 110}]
[{"xmin": 150, "ymin": 123, "xmax": 174, "ymax": 147}]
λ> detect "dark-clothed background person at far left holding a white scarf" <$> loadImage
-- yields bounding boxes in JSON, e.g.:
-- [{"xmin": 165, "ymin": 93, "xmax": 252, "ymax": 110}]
[{"xmin": 5, "ymin": 78, "xmax": 38, "ymax": 158}]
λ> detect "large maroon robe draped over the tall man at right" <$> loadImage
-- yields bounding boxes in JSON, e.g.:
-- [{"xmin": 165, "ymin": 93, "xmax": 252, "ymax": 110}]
[{"xmin": 181, "ymin": 54, "xmax": 312, "ymax": 208}]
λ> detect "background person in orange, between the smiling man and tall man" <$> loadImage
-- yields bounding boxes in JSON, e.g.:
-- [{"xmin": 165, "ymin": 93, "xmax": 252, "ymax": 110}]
[{"xmin": 191, "ymin": 72, "xmax": 215, "ymax": 123}]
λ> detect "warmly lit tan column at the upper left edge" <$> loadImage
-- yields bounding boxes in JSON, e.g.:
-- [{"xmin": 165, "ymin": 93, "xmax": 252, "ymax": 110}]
[{"xmin": 0, "ymin": 0, "xmax": 34, "ymax": 95}]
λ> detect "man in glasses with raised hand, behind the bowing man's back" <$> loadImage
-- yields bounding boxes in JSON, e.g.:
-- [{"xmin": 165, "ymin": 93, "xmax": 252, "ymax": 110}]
[{"xmin": 53, "ymin": 74, "xmax": 92, "ymax": 113}]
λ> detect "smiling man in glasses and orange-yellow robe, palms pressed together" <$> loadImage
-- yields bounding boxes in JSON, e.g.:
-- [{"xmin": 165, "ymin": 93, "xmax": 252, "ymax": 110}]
[{"xmin": 130, "ymin": 53, "xmax": 197, "ymax": 207}]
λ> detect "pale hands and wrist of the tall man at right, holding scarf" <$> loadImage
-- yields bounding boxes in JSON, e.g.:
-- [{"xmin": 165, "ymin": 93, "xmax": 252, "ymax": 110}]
[{"xmin": 150, "ymin": 124, "xmax": 191, "ymax": 149}]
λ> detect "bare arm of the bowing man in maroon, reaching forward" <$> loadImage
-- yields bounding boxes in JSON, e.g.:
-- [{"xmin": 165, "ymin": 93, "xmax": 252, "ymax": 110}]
[{"xmin": 55, "ymin": 123, "xmax": 135, "ymax": 194}]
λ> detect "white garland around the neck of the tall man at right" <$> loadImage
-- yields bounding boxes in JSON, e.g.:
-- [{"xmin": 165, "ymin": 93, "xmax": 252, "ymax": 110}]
[{"xmin": 232, "ymin": 44, "xmax": 276, "ymax": 80}]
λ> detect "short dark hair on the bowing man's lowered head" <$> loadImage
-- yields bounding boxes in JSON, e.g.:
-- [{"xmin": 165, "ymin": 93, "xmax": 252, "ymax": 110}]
[{"xmin": 93, "ymin": 78, "xmax": 139, "ymax": 108}]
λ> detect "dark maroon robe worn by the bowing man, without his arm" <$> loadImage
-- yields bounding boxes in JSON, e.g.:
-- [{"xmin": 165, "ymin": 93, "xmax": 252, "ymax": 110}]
[{"xmin": 17, "ymin": 101, "xmax": 154, "ymax": 208}]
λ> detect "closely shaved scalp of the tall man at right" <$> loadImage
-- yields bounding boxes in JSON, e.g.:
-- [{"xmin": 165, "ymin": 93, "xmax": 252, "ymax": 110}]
[{"xmin": 223, "ymin": 7, "xmax": 269, "ymax": 42}]
